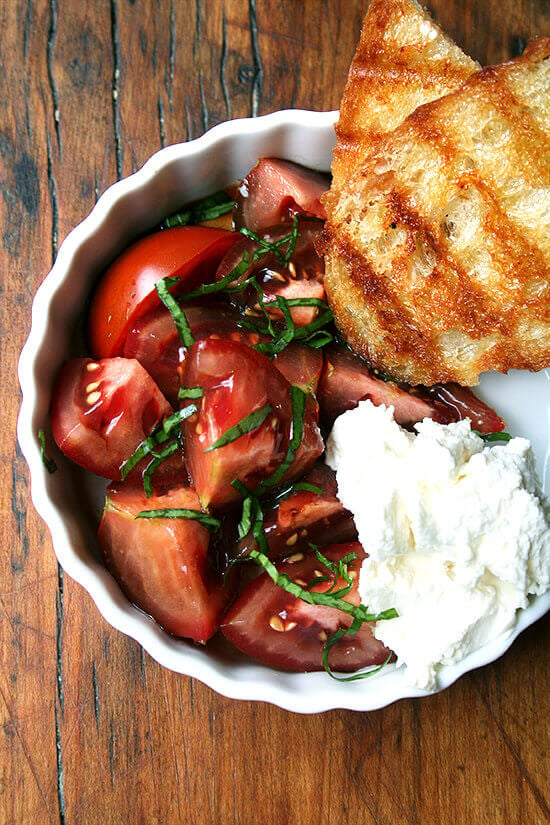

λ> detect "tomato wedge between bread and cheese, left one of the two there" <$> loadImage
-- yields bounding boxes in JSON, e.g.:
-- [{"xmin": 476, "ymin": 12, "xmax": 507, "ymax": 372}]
[{"xmin": 318, "ymin": 345, "xmax": 442, "ymax": 425}]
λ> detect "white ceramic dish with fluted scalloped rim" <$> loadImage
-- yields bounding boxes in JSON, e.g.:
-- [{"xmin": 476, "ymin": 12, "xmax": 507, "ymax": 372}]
[{"xmin": 18, "ymin": 110, "xmax": 550, "ymax": 713}]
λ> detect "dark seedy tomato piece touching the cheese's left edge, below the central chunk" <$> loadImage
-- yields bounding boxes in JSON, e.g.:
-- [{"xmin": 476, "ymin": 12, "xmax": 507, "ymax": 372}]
[{"xmin": 237, "ymin": 461, "xmax": 357, "ymax": 559}]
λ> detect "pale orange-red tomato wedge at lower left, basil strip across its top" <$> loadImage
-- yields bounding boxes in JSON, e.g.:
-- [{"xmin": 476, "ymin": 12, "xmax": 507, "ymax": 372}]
[{"xmin": 99, "ymin": 483, "xmax": 233, "ymax": 643}]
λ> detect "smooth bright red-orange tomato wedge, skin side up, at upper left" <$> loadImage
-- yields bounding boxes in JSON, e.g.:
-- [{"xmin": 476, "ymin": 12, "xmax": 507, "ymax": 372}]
[{"xmin": 89, "ymin": 226, "xmax": 239, "ymax": 358}]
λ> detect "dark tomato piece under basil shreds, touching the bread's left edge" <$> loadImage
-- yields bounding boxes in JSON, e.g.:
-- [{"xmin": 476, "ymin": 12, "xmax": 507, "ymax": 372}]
[{"xmin": 216, "ymin": 219, "xmax": 325, "ymax": 326}]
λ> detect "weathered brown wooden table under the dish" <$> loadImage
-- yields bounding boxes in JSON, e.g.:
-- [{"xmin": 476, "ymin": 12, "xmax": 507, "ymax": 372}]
[{"xmin": 0, "ymin": 0, "xmax": 550, "ymax": 825}]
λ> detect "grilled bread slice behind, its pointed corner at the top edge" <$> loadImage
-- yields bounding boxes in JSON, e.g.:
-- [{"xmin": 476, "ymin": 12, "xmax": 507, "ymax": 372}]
[{"xmin": 327, "ymin": 0, "xmax": 479, "ymax": 203}]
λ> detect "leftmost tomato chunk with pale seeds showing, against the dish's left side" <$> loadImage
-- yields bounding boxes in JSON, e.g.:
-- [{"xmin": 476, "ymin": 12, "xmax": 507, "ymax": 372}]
[{"xmin": 51, "ymin": 358, "xmax": 185, "ymax": 480}]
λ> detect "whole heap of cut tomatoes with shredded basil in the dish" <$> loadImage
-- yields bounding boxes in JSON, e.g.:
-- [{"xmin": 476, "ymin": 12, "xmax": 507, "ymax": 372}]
[{"xmin": 42, "ymin": 158, "xmax": 504, "ymax": 678}]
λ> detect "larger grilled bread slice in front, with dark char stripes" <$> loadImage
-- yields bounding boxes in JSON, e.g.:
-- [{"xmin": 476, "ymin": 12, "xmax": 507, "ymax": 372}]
[{"xmin": 324, "ymin": 38, "xmax": 550, "ymax": 385}]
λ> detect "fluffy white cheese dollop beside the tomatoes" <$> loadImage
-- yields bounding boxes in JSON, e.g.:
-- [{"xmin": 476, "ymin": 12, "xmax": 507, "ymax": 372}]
[{"xmin": 326, "ymin": 401, "xmax": 550, "ymax": 689}]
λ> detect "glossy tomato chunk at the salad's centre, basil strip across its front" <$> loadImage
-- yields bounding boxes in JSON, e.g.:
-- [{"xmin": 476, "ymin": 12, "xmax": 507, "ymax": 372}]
[{"xmin": 183, "ymin": 338, "xmax": 323, "ymax": 508}]
